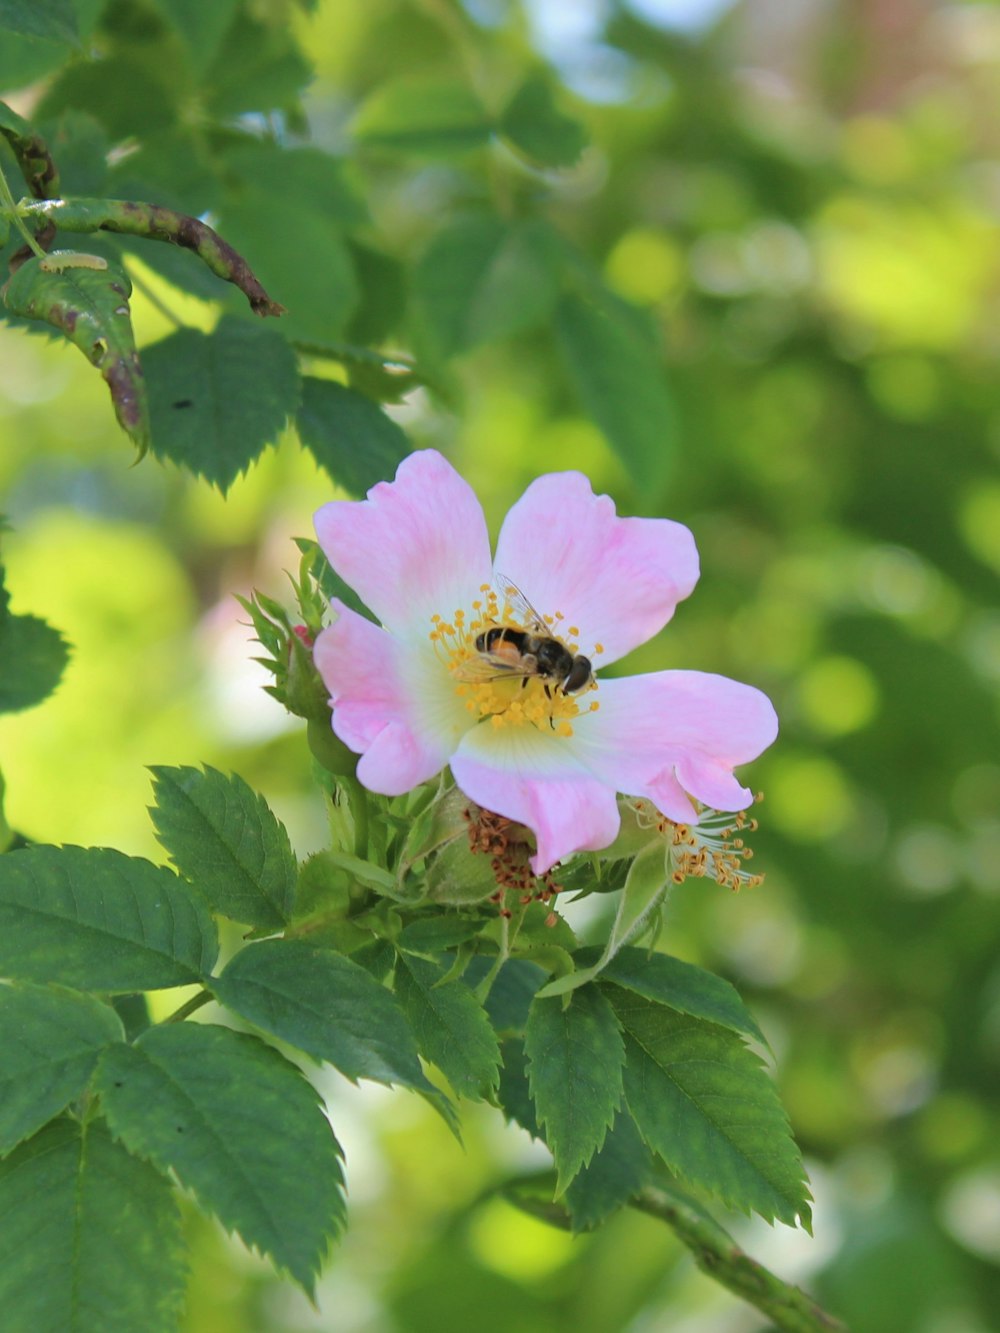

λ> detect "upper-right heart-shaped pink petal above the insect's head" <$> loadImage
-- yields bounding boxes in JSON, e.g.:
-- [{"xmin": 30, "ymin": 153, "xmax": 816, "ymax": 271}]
[{"xmin": 495, "ymin": 472, "xmax": 697, "ymax": 668}]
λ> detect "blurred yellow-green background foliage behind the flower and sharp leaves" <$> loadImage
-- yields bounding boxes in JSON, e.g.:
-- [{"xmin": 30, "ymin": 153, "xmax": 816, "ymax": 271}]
[{"xmin": 0, "ymin": 0, "xmax": 1000, "ymax": 1333}]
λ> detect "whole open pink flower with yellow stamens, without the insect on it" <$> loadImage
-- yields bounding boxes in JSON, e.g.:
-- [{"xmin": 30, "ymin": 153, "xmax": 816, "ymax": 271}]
[{"xmin": 315, "ymin": 449, "xmax": 777, "ymax": 874}]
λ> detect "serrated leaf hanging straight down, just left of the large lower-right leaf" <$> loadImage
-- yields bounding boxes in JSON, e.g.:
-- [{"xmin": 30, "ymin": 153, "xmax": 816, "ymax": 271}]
[{"xmin": 524, "ymin": 986, "xmax": 625, "ymax": 1193}]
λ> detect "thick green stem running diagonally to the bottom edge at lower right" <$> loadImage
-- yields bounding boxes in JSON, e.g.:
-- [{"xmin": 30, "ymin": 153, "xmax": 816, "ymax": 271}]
[{"xmin": 632, "ymin": 1185, "xmax": 847, "ymax": 1333}]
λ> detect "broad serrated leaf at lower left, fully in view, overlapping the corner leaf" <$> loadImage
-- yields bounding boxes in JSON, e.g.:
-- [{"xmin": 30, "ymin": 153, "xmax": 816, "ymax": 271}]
[{"xmin": 96, "ymin": 1022, "xmax": 344, "ymax": 1294}]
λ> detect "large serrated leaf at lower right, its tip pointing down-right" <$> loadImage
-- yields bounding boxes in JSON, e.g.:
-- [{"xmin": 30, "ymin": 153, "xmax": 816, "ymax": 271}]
[{"xmin": 610, "ymin": 986, "xmax": 809, "ymax": 1226}]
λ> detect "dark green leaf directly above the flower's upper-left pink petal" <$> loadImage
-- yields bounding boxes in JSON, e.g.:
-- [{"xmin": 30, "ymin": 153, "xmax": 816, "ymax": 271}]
[{"xmin": 296, "ymin": 377, "xmax": 411, "ymax": 496}]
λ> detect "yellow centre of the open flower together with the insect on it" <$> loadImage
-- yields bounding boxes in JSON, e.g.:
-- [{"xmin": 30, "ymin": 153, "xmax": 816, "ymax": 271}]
[{"xmin": 429, "ymin": 584, "xmax": 603, "ymax": 736}]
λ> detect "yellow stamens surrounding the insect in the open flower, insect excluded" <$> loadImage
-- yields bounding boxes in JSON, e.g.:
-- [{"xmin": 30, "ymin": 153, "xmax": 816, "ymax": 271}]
[{"xmin": 429, "ymin": 584, "xmax": 600, "ymax": 736}]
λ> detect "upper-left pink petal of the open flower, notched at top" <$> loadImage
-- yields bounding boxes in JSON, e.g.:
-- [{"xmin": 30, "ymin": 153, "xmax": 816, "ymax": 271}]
[{"xmin": 315, "ymin": 449, "xmax": 491, "ymax": 633}]
